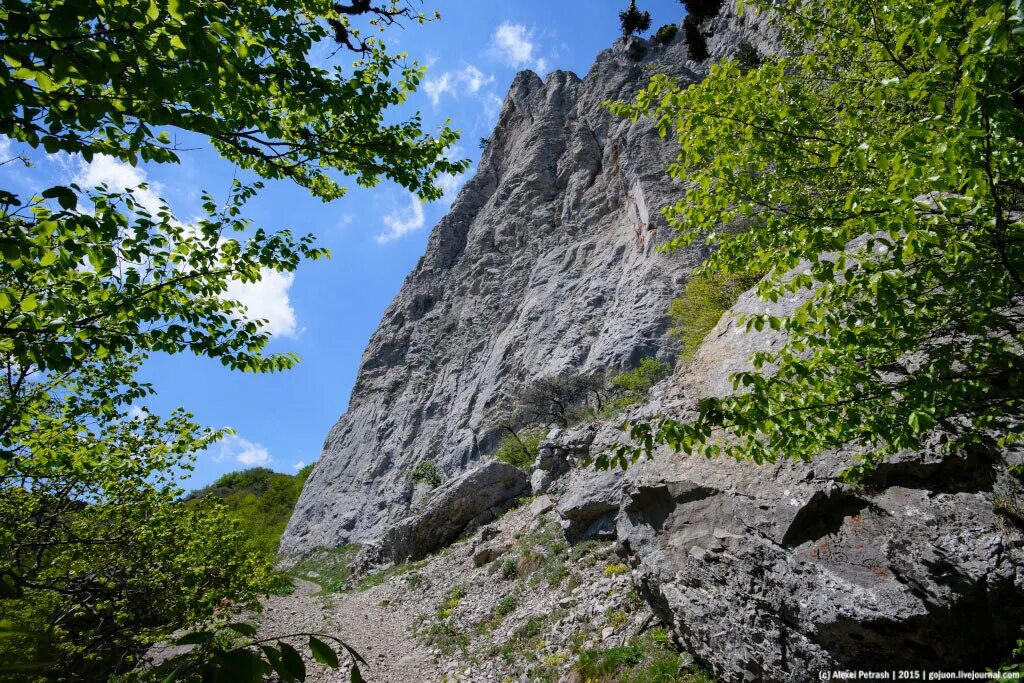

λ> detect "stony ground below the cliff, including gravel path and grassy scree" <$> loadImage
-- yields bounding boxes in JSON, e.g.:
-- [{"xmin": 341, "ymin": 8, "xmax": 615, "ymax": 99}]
[{"xmin": 260, "ymin": 499, "xmax": 699, "ymax": 683}]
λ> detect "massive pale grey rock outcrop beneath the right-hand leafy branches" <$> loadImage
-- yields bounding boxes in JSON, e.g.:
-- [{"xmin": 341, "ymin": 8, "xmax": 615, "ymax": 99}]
[{"xmin": 551, "ymin": 292, "xmax": 1024, "ymax": 681}]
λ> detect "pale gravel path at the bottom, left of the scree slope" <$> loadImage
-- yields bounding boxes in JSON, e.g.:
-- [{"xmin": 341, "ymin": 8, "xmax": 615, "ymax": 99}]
[{"xmin": 260, "ymin": 581, "xmax": 440, "ymax": 683}]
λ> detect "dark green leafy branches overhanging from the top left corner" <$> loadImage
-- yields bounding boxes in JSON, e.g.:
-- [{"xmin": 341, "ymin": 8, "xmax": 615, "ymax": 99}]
[{"xmin": 0, "ymin": 0, "xmax": 464, "ymax": 199}]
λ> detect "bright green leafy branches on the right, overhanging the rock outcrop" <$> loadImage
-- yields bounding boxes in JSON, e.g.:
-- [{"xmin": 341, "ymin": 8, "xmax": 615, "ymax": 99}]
[{"xmin": 604, "ymin": 0, "xmax": 1024, "ymax": 477}]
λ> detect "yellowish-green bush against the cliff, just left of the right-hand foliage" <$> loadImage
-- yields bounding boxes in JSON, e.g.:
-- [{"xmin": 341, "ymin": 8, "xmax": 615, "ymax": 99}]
[{"xmin": 669, "ymin": 273, "xmax": 760, "ymax": 360}]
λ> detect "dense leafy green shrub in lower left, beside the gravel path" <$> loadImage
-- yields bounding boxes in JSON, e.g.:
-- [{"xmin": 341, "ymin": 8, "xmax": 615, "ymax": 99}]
[{"xmin": 0, "ymin": 357, "xmax": 268, "ymax": 681}]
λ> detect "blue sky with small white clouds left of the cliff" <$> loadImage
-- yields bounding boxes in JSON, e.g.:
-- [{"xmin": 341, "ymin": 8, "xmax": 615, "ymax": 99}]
[{"xmin": 0, "ymin": 0, "xmax": 684, "ymax": 488}]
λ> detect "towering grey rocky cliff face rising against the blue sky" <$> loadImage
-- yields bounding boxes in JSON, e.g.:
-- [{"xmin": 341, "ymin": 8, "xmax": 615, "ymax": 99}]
[{"xmin": 282, "ymin": 6, "xmax": 769, "ymax": 556}]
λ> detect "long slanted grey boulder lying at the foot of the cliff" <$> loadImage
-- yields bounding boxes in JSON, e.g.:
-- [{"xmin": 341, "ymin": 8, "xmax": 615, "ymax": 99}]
[{"xmin": 374, "ymin": 461, "xmax": 529, "ymax": 562}]
